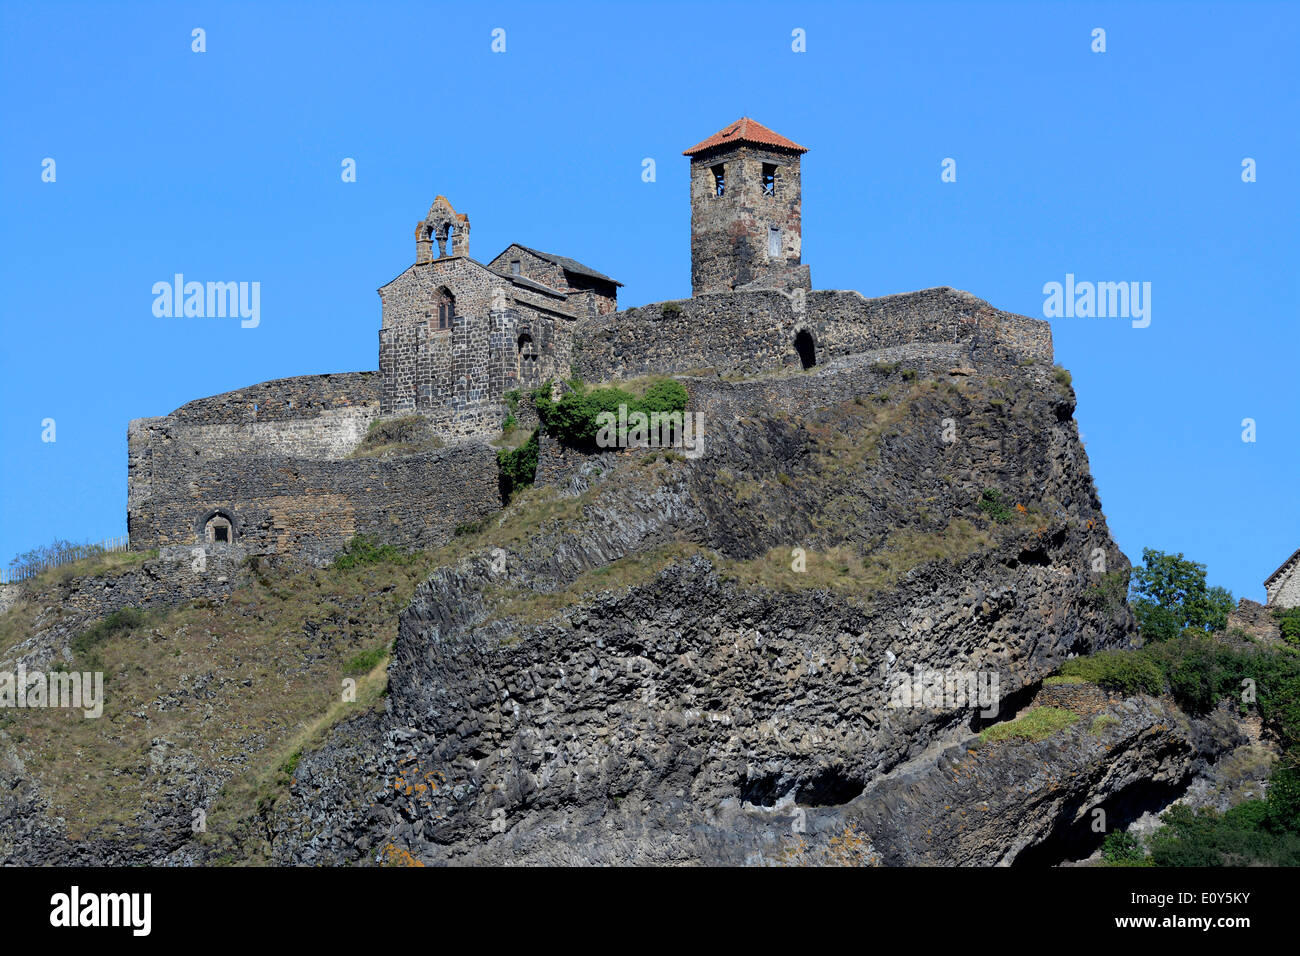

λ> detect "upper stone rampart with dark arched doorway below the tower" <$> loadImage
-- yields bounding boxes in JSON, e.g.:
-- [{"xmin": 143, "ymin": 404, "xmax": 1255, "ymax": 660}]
[{"xmin": 575, "ymin": 287, "xmax": 1052, "ymax": 381}]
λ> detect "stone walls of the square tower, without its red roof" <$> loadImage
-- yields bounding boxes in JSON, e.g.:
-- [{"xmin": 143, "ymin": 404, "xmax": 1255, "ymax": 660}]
[{"xmin": 690, "ymin": 146, "xmax": 802, "ymax": 295}]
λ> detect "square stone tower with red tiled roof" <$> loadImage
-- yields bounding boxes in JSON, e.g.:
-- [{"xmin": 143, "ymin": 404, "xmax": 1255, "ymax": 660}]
[{"xmin": 683, "ymin": 117, "xmax": 811, "ymax": 295}]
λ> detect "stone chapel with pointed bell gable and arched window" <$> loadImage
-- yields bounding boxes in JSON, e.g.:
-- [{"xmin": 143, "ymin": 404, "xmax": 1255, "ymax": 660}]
[{"xmin": 380, "ymin": 196, "xmax": 621, "ymax": 437}]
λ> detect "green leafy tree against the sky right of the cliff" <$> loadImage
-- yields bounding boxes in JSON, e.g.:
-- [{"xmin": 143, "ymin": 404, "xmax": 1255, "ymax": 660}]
[{"xmin": 1130, "ymin": 548, "xmax": 1232, "ymax": 641}]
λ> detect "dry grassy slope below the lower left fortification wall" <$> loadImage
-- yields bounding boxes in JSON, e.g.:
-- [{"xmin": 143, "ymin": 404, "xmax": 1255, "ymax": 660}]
[{"xmin": 5, "ymin": 561, "xmax": 430, "ymax": 839}]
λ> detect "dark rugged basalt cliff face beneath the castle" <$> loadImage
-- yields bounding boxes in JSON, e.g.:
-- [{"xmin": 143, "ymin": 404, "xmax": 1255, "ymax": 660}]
[{"xmin": 269, "ymin": 364, "xmax": 1144, "ymax": 864}]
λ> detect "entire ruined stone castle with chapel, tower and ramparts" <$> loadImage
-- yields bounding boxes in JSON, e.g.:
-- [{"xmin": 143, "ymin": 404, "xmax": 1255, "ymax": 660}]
[{"xmin": 127, "ymin": 117, "xmax": 1052, "ymax": 562}]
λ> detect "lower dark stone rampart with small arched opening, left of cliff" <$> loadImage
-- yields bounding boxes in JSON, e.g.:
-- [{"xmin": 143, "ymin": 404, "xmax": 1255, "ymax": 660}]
[{"xmin": 129, "ymin": 441, "xmax": 501, "ymax": 562}]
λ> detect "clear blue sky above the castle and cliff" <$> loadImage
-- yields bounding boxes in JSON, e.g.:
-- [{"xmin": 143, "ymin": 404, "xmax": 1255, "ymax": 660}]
[{"xmin": 0, "ymin": 0, "xmax": 1300, "ymax": 600}]
